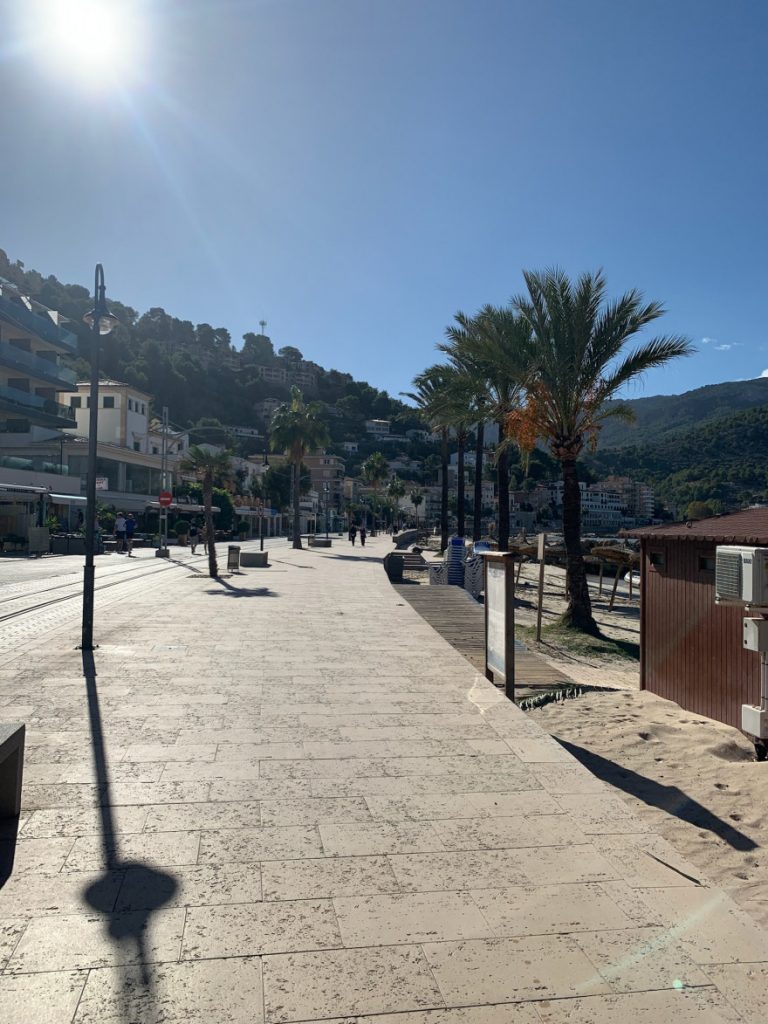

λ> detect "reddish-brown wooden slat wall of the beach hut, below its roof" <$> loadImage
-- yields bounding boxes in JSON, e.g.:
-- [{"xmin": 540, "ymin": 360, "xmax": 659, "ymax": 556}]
[{"xmin": 643, "ymin": 541, "xmax": 760, "ymax": 729}]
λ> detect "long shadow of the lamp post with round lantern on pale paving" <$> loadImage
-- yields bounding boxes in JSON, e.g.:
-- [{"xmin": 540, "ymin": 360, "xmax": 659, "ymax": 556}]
[{"xmin": 82, "ymin": 650, "xmax": 178, "ymax": 1011}]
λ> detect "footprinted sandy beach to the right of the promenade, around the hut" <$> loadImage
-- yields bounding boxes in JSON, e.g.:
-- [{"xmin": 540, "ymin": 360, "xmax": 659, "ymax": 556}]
[{"xmin": 517, "ymin": 564, "xmax": 768, "ymax": 926}]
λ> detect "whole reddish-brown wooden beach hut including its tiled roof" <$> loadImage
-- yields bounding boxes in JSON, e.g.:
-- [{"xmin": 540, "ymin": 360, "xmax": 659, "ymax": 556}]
[{"xmin": 628, "ymin": 508, "xmax": 768, "ymax": 729}]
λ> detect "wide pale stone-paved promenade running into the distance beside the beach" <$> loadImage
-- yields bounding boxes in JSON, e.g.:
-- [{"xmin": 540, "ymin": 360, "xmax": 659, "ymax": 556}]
[{"xmin": 0, "ymin": 538, "xmax": 768, "ymax": 1024}]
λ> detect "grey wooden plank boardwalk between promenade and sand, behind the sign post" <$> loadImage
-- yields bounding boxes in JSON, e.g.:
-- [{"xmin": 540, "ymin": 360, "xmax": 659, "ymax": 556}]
[{"xmin": 394, "ymin": 583, "xmax": 571, "ymax": 699}]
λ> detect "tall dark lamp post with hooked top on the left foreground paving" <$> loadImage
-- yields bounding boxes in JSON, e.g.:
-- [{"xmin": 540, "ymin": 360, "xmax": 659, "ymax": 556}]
[{"xmin": 80, "ymin": 263, "xmax": 118, "ymax": 650}]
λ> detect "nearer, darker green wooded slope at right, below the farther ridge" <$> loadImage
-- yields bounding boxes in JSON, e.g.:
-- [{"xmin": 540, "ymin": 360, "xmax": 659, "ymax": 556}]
[{"xmin": 587, "ymin": 399, "xmax": 768, "ymax": 515}]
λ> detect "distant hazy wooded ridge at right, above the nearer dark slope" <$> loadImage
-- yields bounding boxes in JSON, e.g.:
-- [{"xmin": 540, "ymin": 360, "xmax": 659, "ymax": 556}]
[{"xmin": 600, "ymin": 377, "xmax": 768, "ymax": 449}]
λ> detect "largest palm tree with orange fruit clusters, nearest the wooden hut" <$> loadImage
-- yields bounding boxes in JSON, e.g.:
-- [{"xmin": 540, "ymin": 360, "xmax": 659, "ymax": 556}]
[{"xmin": 506, "ymin": 268, "xmax": 693, "ymax": 634}]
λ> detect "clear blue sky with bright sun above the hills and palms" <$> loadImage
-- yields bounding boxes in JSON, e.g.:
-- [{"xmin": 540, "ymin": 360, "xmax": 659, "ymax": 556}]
[{"xmin": 0, "ymin": 0, "xmax": 768, "ymax": 394}]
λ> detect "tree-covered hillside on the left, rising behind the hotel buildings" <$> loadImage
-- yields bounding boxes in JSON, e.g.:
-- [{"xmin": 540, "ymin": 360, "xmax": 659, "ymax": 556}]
[{"xmin": 0, "ymin": 250, "xmax": 421, "ymax": 442}]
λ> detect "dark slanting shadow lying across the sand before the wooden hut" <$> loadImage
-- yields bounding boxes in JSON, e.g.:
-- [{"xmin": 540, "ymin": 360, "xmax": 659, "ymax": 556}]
[{"xmin": 555, "ymin": 737, "xmax": 758, "ymax": 850}]
